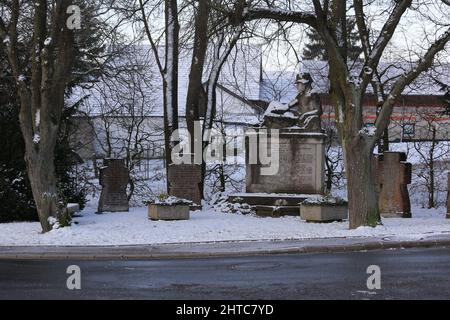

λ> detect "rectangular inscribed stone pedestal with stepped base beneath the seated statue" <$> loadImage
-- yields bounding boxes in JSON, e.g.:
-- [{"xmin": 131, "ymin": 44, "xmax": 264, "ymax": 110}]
[{"xmin": 230, "ymin": 128, "xmax": 326, "ymax": 217}]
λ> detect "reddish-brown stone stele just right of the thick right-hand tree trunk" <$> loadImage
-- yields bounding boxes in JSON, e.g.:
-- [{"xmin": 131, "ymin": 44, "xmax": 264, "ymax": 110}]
[{"xmin": 374, "ymin": 152, "xmax": 412, "ymax": 218}]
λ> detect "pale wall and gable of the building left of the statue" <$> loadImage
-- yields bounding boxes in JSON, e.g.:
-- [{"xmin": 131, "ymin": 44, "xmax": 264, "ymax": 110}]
[{"xmin": 71, "ymin": 90, "xmax": 259, "ymax": 160}]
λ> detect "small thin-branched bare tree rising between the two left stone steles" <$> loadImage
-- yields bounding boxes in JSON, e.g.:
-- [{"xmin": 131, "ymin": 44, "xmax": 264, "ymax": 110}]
[{"xmin": 85, "ymin": 45, "xmax": 164, "ymax": 200}]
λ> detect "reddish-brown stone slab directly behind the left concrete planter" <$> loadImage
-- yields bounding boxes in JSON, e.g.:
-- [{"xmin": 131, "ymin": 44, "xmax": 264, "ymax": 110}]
[{"xmin": 168, "ymin": 164, "xmax": 202, "ymax": 210}]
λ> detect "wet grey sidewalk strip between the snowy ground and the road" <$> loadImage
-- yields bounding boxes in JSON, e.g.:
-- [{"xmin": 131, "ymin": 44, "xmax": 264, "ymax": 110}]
[{"xmin": 0, "ymin": 235, "xmax": 450, "ymax": 260}]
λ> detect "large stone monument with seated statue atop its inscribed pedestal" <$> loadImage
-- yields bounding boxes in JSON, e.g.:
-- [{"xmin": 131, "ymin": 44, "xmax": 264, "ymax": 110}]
[{"xmin": 230, "ymin": 74, "xmax": 326, "ymax": 216}]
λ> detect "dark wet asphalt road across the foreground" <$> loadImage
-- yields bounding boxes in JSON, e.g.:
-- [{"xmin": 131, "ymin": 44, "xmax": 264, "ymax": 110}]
[{"xmin": 0, "ymin": 249, "xmax": 450, "ymax": 299}]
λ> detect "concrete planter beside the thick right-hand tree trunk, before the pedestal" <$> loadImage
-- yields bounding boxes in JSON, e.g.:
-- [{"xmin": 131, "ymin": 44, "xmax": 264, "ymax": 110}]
[{"xmin": 300, "ymin": 204, "xmax": 348, "ymax": 222}]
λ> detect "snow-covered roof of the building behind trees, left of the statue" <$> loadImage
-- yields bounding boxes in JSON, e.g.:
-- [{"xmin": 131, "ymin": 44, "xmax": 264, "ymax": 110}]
[{"xmin": 69, "ymin": 45, "xmax": 261, "ymax": 116}]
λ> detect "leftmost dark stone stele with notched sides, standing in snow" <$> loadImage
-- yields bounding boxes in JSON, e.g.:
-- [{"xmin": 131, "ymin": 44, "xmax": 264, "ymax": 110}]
[{"xmin": 98, "ymin": 159, "xmax": 129, "ymax": 213}]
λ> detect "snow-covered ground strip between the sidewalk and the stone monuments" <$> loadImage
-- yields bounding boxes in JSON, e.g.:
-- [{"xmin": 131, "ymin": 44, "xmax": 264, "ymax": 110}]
[{"xmin": 0, "ymin": 207, "xmax": 450, "ymax": 246}]
